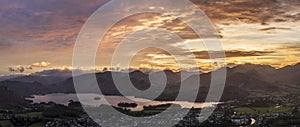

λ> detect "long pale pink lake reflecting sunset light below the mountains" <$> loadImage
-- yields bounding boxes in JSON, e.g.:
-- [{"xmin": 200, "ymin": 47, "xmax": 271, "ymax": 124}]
[{"xmin": 27, "ymin": 93, "xmax": 219, "ymax": 111}]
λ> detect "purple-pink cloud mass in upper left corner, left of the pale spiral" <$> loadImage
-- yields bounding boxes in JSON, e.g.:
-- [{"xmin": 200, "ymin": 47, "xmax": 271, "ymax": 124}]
[{"xmin": 0, "ymin": 0, "xmax": 108, "ymax": 50}]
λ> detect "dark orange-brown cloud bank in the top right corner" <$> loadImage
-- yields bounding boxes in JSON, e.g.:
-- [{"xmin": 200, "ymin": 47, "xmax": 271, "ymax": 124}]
[{"xmin": 192, "ymin": 0, "xmax": 300, "ymax": 24}]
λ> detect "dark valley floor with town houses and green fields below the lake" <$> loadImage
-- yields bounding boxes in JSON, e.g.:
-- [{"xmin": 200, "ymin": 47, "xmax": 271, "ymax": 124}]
[{"xmin": 0, "ymin": 92, "xmax": 300, "ymax": 127}]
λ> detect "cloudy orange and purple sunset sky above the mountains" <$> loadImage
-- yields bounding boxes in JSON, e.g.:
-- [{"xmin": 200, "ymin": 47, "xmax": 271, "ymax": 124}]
[{"xmin": 0, "ymin": 0, "xmax": 300, "ymax": 75}]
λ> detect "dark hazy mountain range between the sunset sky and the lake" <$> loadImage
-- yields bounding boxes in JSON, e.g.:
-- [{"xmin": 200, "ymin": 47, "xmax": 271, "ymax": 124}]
[{"xmin": 0, "ymin": 63, "xmax": 300, "ymax": 103}]
